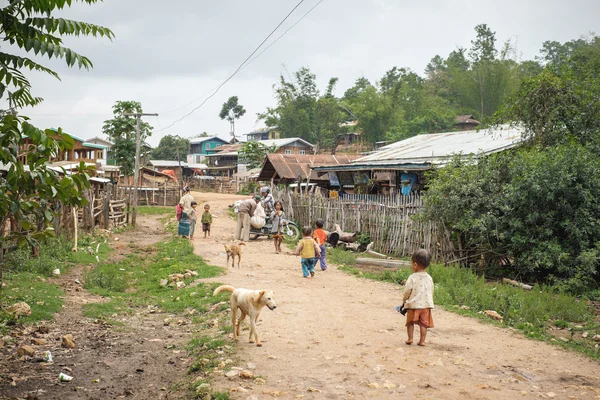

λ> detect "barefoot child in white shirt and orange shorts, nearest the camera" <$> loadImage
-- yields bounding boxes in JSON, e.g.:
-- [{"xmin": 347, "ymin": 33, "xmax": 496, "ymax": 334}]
[{"xmin": 396, "ymin": 249, "xmax": 433, "ymax": 346}]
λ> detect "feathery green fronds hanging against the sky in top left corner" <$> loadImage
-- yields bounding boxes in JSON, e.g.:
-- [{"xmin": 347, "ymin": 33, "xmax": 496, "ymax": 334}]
[{"xmin": 0, "ymin": 0, "xmax": 114, "ymax": 108}]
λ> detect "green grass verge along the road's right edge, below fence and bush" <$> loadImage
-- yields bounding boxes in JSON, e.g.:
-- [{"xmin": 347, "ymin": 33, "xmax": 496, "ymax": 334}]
[{"xmin": 328, "ymin": 249, "xmax": 600, "ymax": 359}]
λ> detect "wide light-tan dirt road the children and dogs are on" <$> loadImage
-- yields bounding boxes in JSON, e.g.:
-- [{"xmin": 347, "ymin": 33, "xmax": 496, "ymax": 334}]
[{"xmin": 194, "ymin": 194, "xmax": 600, "ymax": 399}]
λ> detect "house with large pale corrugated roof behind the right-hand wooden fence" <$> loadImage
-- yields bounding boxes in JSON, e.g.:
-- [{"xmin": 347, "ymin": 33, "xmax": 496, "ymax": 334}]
[{"xmin": 312, "ymin": 127, "xmax": 523, "ymax": 195}]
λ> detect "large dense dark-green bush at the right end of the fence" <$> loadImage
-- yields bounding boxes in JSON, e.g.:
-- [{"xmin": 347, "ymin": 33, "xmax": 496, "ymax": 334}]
[{"xmin": 425, "ymin": 144, "xmax": 600, "ymax": 293}]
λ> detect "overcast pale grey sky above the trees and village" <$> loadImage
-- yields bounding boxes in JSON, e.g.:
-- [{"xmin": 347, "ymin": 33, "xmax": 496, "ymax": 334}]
[{"xmin": 10, "ymin": 0, "xmax": 600, "ymax": 145}]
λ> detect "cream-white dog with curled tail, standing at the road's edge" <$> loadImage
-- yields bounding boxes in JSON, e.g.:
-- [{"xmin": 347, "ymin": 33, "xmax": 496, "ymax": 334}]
[{"xmin": 213, "ymin": 285, "xmax": 277, "ymax": 347}]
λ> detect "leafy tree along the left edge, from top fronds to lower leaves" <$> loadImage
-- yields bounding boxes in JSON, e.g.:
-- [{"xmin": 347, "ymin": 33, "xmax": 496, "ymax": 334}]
[{"xmin": 0, "ymin": 0, "xmax": 113, "ymax": 288}]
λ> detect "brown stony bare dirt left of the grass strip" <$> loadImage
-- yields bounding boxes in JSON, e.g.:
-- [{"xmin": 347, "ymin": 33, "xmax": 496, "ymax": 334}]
[{"xmin": 0, "ymin": 217, "xmax": 191, "ymax": 400}]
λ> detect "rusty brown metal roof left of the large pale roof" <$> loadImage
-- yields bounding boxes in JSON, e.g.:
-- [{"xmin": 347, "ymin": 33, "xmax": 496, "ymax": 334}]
[{"xmin": 258, "ymin": 154, "xmax": 360, "ymax": 181}]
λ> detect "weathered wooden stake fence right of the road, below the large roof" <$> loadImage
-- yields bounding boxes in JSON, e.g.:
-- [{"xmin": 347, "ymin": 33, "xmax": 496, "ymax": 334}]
[{"xmin": 274, "ymin": 191, "xmax": 455, "ymax": 261}]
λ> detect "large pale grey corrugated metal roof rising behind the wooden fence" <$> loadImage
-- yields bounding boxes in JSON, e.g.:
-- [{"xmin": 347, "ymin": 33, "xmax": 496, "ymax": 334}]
[{"xmin": 316, "ymin": 127, "xmax": 523, "ymax": 171}]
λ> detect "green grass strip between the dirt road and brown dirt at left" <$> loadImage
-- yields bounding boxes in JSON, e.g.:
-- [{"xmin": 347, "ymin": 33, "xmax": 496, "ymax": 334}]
[{"xmin": 84, "ymin": 238, "xmax": 233, "ymax": 399}]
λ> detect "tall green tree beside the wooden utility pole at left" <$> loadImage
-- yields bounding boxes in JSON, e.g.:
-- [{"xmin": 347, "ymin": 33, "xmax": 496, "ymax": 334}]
[{"xmin": 102, "ymin": 101, "xmax": 153, "ymax": 176}]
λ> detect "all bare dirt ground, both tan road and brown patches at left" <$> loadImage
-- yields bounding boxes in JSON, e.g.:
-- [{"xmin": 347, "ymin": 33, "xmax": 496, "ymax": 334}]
[{"xmin": 0, "ymin": 193, "xmax": 600, "ymax": 399}]
